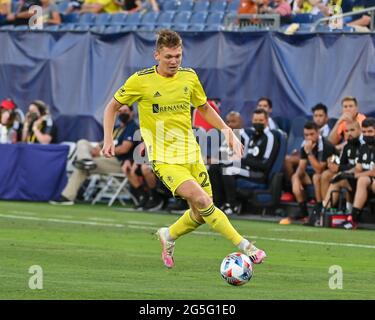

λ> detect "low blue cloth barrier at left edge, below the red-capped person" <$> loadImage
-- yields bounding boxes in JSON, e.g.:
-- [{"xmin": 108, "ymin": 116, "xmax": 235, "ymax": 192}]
[{"xmin": 0, "ymin": 143, "xmax": 69, "ymax": 201}]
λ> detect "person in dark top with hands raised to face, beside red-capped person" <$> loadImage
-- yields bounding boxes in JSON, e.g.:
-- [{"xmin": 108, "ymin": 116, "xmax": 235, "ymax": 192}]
[{"xmin": 22, "ymin": 100, "xmax": 57, "ymax": 144}]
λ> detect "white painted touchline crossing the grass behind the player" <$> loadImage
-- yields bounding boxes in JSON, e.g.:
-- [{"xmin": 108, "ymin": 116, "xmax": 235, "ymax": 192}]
[{"xmin": 0, "ymin": 214, "xmax": 375, "ymax": 249}]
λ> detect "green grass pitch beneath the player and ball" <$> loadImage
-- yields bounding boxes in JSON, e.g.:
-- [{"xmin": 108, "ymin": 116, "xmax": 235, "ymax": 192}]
[{"xmin": 0, "ymin": 201, "xmax": 375, "ymax": 300}]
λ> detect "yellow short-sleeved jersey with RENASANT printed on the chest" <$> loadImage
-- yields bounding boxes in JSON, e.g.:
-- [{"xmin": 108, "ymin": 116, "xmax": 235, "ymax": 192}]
[{"xmin": 114, "ymin": 66, "xmax": 207, "ymax": 164}]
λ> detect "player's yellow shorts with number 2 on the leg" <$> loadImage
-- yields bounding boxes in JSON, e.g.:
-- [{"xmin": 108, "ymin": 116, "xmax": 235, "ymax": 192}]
[{"xmin": 151, "ymin": 161, "xmax": 212, "ymax": 197}]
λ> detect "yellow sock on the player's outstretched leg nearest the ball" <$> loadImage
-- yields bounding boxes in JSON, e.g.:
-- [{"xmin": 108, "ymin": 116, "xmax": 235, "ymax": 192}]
[{"xmin": 199, "ymin": 203, "xmax": 243, "ymax": 246}]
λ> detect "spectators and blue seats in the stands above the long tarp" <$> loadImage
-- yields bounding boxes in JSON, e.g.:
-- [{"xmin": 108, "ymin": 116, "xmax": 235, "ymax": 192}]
[{"xmin": 0, "ymin": 0, "xmax": 375, "ymax": 31}]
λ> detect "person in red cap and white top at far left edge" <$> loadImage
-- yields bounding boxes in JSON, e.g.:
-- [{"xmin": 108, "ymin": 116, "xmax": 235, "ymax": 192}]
[{"xmin": 0, "ymin": 99, "xmax": 22, "ymax": 143}]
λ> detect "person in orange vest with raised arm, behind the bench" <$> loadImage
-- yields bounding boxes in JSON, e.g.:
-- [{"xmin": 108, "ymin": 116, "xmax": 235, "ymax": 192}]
[{"xmin": 328, "ymin": 96, "xmax": 366, "ymax": 151}]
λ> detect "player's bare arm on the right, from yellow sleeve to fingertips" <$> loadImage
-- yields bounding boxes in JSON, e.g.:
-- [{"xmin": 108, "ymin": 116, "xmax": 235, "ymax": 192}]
[{"xmin": 198, "ymin": 102, "xmax": 244, "ymax": 159}]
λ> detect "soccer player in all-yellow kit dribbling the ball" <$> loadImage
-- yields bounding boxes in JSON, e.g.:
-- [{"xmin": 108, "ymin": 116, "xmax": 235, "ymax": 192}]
[{"xmin": 102, "ymin": 30, "xmax": 266, "ymax": 268}]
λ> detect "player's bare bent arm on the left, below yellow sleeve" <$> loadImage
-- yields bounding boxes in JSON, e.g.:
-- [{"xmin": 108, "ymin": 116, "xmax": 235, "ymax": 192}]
[{"xmin": 102, "ymin": 98, "xmax": 121, "ymax": 158}]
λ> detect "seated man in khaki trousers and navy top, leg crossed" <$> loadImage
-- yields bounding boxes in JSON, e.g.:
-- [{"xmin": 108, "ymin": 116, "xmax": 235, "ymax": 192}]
[{"xmin": 50, "ymin": 106, "xmax": 138, "ymax": 205}]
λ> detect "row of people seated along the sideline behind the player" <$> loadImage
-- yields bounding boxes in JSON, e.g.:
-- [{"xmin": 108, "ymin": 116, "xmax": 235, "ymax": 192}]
[{"xmin": 0, "ymin": 92, "xmax": 375, "ymax": 228}]
